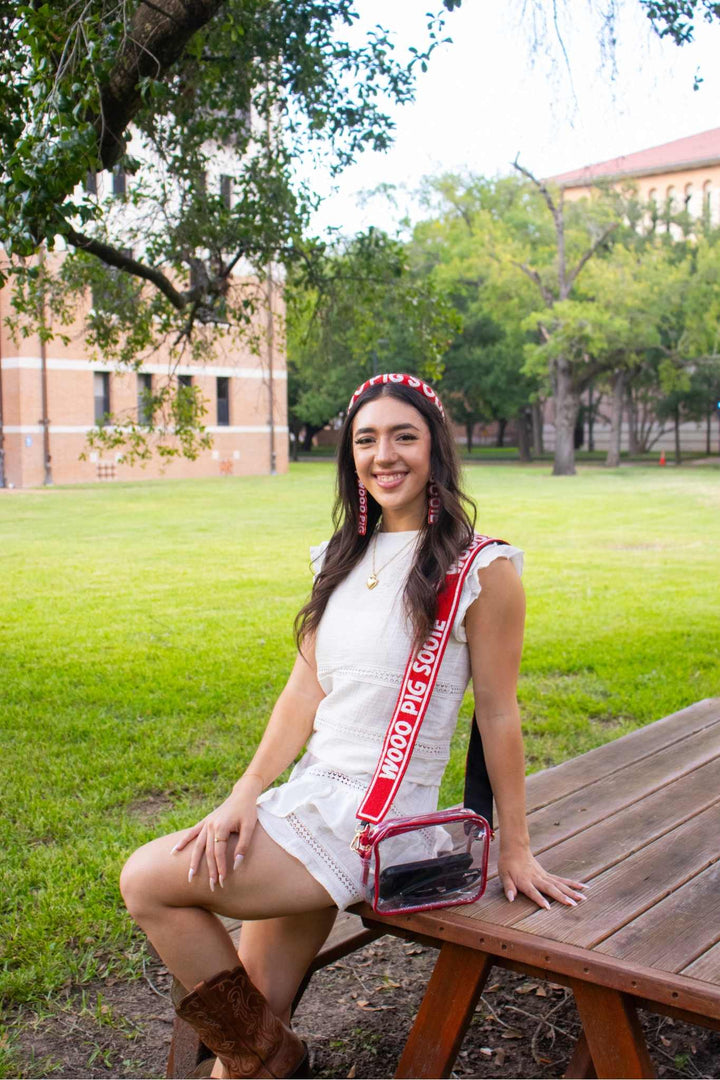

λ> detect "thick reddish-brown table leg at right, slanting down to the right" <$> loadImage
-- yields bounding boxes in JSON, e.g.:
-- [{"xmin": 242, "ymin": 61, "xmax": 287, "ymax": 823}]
[{"xmin": 571, "ymin": 978, "xmax": 655, "ymax": 1080}]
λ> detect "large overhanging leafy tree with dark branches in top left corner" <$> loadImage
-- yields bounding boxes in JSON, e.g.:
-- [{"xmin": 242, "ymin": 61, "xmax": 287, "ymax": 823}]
[{"xmin": 0, "ymin": 0, "xmax": 459, "ymax": 457}]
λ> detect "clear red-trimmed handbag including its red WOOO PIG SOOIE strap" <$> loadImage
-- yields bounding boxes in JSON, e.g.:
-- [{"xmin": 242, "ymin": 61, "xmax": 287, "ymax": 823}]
[{"xmin": 352, "ymin": 536, "xmax": 503, "ymax": 915}]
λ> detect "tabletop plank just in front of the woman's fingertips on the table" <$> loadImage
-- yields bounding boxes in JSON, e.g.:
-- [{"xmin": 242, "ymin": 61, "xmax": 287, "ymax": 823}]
[{"xmin": 515, "ymin": 804, "xmax": 720, "ymax": 948}]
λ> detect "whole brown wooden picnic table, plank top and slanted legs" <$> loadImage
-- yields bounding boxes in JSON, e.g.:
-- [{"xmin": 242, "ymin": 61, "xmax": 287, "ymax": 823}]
[{"xmin": 353, "ymin": 698, "xmax": 720, "ymax": 1077}]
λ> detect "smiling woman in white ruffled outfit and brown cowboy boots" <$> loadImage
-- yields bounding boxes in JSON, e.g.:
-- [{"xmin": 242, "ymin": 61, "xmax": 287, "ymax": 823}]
[{"xmin": 121, "ymin": 375, "xmax": 583, "ymax": 1077}]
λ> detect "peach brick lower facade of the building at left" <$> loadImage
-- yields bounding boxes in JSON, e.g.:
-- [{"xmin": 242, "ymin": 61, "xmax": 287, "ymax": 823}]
[{"xmin": 0, "ymin": 270, "xmax": 288, "ymax": 487}]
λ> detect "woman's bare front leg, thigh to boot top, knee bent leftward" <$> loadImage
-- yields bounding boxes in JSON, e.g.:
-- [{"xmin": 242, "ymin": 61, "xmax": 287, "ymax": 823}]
[{"xmin": 120, "ymin": 824, "xmax": 335, "ymax": 1001}]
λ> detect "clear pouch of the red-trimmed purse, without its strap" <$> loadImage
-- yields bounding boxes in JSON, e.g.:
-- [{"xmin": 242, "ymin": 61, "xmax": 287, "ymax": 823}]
[{"xmin": 356, "ymin": 807, "xmax": 492, "ymax": 915}]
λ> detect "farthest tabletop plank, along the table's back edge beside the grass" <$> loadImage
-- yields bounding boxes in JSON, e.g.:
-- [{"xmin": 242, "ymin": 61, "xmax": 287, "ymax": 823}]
[{"xmin": 528, "ymin": 698, "xmax": 720, "ymax": 810}]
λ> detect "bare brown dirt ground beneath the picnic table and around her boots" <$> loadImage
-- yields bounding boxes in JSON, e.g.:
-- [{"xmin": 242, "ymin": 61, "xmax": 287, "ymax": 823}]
[{"xmin": 7, "ymin": 937, "xmax": 720, "ymax": 1080}]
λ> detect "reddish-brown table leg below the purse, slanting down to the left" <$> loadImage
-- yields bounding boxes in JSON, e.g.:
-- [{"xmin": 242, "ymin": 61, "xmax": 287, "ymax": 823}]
[{"xmin": 395, "ymin": 942, "xmax": 492, "ymax": 1078}]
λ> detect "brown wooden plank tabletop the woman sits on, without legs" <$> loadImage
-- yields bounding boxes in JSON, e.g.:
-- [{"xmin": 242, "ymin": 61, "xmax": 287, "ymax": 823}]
[{"xmin": 361, "ymin": 698, "xmax": 720, "ymax": 1075}]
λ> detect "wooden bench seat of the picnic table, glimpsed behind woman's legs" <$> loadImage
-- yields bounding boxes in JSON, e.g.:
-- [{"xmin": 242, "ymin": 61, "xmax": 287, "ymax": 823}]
[{"xmin": 166, "ymin": 912, "xmax": 385, "ymax": 1078}]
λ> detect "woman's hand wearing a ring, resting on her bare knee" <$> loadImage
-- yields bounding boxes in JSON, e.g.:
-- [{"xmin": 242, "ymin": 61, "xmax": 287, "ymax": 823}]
[{"xmin": 172, "ymin": 773, "xmax": 262, "ymax": 892}]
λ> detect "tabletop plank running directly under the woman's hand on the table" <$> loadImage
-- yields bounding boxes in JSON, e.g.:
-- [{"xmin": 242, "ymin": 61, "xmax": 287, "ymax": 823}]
[{"xmin": 465, "ymin": 758, "xmax": 720, "ymax": 926}]
